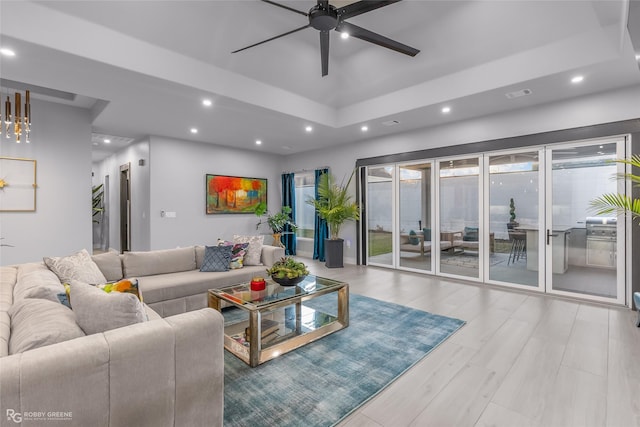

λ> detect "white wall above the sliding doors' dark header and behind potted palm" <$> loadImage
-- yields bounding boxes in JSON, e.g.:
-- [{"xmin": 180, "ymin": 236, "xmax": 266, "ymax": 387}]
[{"xmin": 285, "ymin": 86, "xmax": 640, "ymax": 263}]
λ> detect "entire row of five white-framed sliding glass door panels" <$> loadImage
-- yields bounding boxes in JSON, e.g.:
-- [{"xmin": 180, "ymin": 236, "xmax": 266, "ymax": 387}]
[{"xmin": 363, "ymin": 137, "xmax": 626, "ymax": 303}]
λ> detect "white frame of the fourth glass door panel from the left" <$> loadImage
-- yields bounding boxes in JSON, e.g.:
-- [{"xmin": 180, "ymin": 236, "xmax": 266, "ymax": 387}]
[{"xmin": 482, "ymin": 146, "xmax": 546, "ymax": 292}]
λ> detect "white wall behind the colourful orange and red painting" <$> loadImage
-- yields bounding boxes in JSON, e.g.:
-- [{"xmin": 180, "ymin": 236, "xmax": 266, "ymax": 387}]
[{"xmin": 149, "ymin": 136, "xmax": 282, "ymax": 249}]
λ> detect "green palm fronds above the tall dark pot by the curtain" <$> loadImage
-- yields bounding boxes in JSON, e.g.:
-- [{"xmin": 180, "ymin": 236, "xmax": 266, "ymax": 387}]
[{"xmin": 306, "ymin": 171, "xmax": 360, "ymax": 240}]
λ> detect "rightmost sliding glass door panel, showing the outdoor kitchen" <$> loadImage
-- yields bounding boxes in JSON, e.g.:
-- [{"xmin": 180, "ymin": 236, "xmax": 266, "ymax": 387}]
[{"xmin": 544, "ymin": 139, "xmax": 625, "ymax": 303}]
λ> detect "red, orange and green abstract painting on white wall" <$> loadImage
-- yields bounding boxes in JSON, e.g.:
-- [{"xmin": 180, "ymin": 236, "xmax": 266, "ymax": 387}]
[{"xmin": 206, "ymin": 174, "xmax": 267, "ymax": 214}]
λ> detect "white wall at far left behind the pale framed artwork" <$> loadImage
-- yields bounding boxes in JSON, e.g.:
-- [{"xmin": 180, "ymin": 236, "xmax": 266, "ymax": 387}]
[{"xmin": 0, "ymin": 99, "xmax": 92, "ymax": 265}]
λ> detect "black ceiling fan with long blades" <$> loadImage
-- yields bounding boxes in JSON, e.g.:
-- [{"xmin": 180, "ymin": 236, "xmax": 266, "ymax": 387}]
[{"xmin": 231, "ymin": 0, "xmax": 420, "ymax": 77}]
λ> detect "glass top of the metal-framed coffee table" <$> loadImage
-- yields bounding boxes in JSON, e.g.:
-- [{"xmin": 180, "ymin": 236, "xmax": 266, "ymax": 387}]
[{"xmin": 210, "ymin": 274, "xmax": 344, "ymax": 309}]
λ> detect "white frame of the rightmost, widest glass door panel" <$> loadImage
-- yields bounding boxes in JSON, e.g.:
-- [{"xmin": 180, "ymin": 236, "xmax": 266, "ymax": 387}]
[{"xmin": 539, "ymin": 135, "xmax": 631, "ymax": 305}]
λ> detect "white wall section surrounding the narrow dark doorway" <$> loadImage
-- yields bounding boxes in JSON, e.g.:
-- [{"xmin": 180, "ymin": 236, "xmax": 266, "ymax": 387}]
[{"xmin": 93, "ymin": 140, "xmax": 151, "ymax": 251}]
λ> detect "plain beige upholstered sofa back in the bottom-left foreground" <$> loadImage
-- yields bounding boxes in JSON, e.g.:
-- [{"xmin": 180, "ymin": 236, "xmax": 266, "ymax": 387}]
[{"xmin": 0, "ymin": 309, "xmax": 224, "ymax": 426}]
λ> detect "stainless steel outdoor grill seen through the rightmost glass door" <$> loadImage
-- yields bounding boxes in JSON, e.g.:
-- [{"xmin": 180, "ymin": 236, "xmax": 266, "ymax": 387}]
[{"xmin": 586, "ymin": 217, "xmax": 617, "ymax": 268}]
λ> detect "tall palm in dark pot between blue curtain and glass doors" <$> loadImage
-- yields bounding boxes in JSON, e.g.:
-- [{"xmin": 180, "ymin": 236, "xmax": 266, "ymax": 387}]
[{"xmin": 306, "ymin": 171, "xmax": 360, "ymax": 268}]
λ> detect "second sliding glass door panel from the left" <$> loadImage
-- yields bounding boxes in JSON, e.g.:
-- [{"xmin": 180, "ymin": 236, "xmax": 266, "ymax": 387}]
[{"xmin": 397, "ymin": 162, "xmax": 432, "ymax": 271}]
